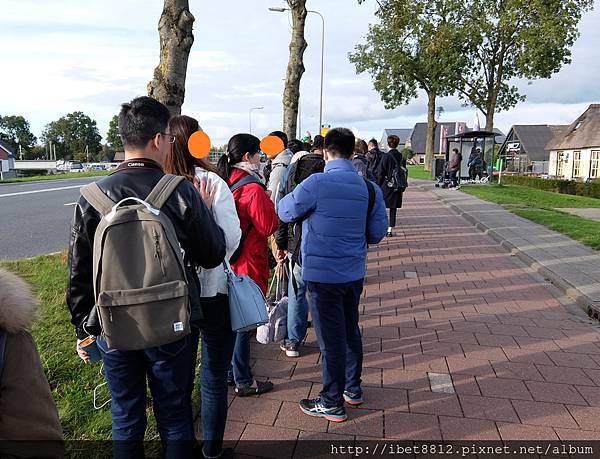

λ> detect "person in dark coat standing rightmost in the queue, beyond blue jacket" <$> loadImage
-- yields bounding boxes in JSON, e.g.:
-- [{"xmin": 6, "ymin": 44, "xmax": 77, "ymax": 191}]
[{"xmin": 374, "ymin": 135, "xmax": 408, "ymax": 237}]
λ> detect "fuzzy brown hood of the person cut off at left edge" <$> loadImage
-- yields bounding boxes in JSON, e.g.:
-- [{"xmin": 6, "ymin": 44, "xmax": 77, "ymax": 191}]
[{"xmin": 0, "ymin": 269, "xmax": 38, "ymax": 333}]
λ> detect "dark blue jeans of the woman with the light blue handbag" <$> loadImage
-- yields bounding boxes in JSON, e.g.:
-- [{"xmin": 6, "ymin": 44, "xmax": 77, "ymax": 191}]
[{"xmin": 192, "ymin": 295, "xmax": 236, "ymax": 457}]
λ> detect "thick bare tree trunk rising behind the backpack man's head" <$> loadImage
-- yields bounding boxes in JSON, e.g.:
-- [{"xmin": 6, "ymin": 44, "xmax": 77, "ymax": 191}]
[{"xmin": 148, "ymin": 0, "xmax": 194, "ymax": 115}]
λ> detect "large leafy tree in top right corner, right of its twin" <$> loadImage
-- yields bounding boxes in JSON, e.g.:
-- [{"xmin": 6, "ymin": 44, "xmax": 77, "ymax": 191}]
[{"xmin": 457, "ymin": 0, "xmax": 593, "ymax": 131}]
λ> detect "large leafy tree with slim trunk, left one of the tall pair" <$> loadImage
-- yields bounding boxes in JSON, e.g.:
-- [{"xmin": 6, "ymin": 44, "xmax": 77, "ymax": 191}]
[{"xmin": 350, "ymin": 0, "xmax": 464, "ymax": 170}]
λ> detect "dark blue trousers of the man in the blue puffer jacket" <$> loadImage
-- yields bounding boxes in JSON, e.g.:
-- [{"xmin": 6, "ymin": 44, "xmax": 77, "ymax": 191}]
[{"xmin": 306, "ymin": 279, "xmax": 364, "ymax": 407}]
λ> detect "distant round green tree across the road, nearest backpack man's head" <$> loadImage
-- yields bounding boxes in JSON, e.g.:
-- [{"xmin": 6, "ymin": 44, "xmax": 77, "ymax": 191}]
[{"xmin": 42, "ymin": 112, "xmax": 102, "ymax": 161}]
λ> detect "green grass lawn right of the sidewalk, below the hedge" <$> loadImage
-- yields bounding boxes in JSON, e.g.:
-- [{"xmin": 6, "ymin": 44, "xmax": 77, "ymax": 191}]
[{"xmin": 461, "ymin": 185, "xmax": 600, "ymax": 249}]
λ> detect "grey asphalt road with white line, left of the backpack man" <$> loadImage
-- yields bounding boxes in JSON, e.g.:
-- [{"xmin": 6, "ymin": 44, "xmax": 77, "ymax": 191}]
[{"xmin": 0, "ymin": 177, "xmax": 101, "ymax": 260}]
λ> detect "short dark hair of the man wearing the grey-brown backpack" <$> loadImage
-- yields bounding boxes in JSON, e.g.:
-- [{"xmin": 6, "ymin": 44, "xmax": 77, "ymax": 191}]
[{"xmin": 119, "ymin": 96, "xmax": 171, "ymax": 149}]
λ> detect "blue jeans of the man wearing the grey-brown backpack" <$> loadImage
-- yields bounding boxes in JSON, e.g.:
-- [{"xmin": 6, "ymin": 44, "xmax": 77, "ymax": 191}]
[{"xmin": 96, "ymin": 335, "xmax": 196, "ymax": 458}]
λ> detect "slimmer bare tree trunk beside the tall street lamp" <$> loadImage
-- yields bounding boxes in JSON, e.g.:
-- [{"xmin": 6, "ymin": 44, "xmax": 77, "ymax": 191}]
[{"xmin": 283, "ymin": 0, "xmax": 307, "ymax": 139}]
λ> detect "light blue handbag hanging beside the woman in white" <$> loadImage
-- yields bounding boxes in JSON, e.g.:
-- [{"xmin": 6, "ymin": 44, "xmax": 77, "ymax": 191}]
[{"xmin": 223, "ymin": 262, "xmax": 269, "ymax": 333}]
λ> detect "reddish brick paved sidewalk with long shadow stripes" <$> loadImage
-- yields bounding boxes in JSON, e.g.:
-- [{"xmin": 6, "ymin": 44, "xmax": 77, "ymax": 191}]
[{"xmin": 218, "ymin": 187, "xmax": 600, "ymax": 457}]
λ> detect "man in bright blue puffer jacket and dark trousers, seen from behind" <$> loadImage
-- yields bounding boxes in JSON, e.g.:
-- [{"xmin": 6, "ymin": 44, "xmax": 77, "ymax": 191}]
[{"xmin": 279, "ymin": 128, "xmax": 388, "ymax": 422}]
